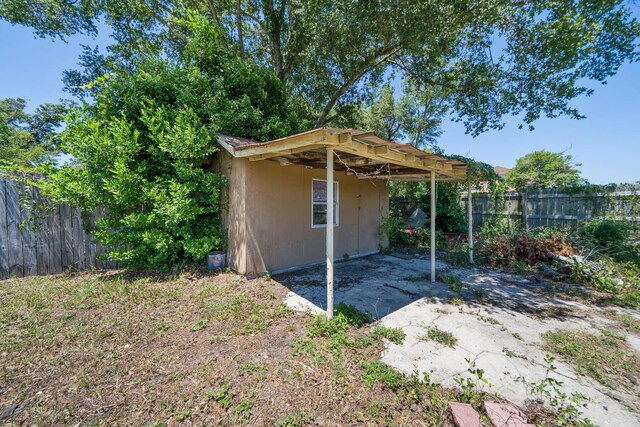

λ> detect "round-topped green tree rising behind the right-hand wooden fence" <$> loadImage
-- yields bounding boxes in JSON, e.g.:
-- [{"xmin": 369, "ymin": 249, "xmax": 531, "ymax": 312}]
[{"xmin": 505, "ymin": 150, "xmax": 585, "ymax": 191}]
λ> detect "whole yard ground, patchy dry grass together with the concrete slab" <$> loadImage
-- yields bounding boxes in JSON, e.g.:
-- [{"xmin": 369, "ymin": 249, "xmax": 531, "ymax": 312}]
[{"xmin": 0, "ymin": 255, "xmax": 640, "ymax": 426}]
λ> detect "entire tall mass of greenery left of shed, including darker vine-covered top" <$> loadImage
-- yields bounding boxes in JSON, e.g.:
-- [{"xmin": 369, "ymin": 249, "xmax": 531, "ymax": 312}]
[{"xmin": 43, "ymin": 25, "xmax": 300, "ymax": 269}]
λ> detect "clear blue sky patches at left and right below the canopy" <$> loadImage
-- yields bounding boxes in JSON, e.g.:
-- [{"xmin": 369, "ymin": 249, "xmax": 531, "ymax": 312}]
[{"xmin": 0, "ymin": 19, "xmax": 640, "ymax": 184}]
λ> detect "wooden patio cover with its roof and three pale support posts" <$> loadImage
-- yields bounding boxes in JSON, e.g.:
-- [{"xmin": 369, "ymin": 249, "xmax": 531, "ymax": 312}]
[{"xmin": 218, "ymin": 127, "xmax": 473, "ymax": 318}]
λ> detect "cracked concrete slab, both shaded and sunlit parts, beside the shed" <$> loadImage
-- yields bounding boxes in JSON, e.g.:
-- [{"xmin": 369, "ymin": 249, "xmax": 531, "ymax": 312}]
[{"xmin": 274, "ymin": 255, "xmax": 640, "ymax": 426}]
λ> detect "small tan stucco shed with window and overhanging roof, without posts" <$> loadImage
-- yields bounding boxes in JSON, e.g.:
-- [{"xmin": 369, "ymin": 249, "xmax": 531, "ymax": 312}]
[{"xmin": 215, "ymin": 128, "xmax": 466, "ymax": 275}]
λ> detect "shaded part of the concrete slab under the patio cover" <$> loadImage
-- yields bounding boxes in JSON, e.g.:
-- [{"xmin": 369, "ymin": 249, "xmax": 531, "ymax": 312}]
[{"xmin": 273, "ymin": 254, "xmax": 584, "ymax": 319}]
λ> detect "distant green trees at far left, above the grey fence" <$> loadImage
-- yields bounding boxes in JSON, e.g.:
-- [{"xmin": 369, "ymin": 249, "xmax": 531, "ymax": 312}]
[{"xmin": 0, "ymin": 98, "xmax": 73, "ymax": 168}]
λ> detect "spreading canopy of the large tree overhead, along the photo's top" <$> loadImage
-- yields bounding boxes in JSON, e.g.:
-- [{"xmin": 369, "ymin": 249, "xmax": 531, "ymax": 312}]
[{"xmin": 0, "ymin": 0, "xmax": 640, "ymax": 135}]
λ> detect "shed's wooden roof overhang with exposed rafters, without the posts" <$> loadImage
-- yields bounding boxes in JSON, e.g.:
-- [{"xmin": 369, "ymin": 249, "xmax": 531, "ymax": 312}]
[{"xmin": 218, "ymin": 127, "xmax": 467, "ymax": 181}]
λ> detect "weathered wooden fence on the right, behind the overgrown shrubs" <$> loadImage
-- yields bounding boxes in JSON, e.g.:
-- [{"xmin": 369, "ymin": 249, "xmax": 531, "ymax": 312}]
[{"xmin": 462, "ymin": 188, "xmax": 640, "ymax": 229}]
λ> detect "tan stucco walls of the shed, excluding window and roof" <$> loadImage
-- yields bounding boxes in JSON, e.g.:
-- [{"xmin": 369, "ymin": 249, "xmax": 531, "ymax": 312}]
[{"xmin": 227, "ymin": 159, "xmax": 388, "ymax": 274}]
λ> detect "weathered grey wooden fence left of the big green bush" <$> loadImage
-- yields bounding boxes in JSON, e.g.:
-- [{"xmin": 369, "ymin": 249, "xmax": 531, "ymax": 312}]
[{"xmin": 0, "ymin": 177, "xmax": 115, "ymax": 278}]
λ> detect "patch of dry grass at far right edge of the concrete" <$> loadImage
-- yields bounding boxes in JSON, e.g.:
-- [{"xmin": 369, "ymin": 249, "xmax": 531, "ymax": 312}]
[{"xmin": 543, "ymin": 331, "xmax": 640, "ymax": 389}]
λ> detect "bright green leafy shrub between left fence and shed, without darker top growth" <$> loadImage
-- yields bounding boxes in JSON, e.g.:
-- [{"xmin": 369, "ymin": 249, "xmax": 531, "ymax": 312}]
[{"xmin": 42, "ymin": 97, "xmax": 225, "ymax": 269}]
